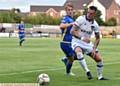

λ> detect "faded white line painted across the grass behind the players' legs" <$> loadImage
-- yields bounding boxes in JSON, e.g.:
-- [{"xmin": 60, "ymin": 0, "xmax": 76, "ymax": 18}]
[{"xmin": 0, "ymin": 62, "xmax": 120, "ymax": 76}]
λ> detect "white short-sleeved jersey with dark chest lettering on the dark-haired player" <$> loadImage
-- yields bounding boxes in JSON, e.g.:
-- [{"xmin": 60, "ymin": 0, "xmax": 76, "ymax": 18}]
[{"xmin": 75, "ymin": 16, "xmax": 99, "ymax": 38}]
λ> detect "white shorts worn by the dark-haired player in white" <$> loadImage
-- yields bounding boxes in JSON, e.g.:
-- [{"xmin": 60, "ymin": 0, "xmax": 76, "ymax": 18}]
[{"xmin": 72, "ymin": 38, "xmax": 98, "ymax": 54}]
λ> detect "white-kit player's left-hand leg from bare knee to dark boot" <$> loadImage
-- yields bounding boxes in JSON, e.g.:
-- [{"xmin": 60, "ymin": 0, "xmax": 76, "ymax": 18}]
[{"xmin": 75, "ymin": 47, "xmax": 92, "ymax": 79}]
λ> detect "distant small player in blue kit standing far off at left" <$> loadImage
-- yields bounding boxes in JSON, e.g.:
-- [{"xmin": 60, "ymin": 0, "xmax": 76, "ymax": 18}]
[{"xmin": 18, "ymin": 21, "xmax": 25, "ymax": 46}]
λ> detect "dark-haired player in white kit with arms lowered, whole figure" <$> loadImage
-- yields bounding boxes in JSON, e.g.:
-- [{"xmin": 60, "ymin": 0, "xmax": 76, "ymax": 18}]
[{"xmin": 71, "ymin": 6, "xmax": 107, "ymax": 80}]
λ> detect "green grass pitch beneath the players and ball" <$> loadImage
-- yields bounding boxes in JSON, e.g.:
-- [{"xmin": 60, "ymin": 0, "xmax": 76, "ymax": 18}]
[{"xmin": 0, "ymin": 38, "xmax": 120, "ymax": 86}]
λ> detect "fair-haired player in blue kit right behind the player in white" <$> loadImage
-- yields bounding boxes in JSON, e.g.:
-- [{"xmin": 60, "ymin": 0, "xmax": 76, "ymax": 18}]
[{"xmin": 60, "ymin": 3, "xmax": 75, "ymax": 75}]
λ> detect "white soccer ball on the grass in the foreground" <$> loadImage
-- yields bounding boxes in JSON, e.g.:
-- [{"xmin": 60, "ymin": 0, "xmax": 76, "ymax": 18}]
[{"xmin": 38, "ymin": 73, "xmax": 50, "ymax": 85}]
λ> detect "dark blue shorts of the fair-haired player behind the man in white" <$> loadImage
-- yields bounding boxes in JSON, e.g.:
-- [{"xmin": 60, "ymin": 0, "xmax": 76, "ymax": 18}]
[{"xmin": 60, "ymin": 42, "xmax": 75, "ymax": 57}]
